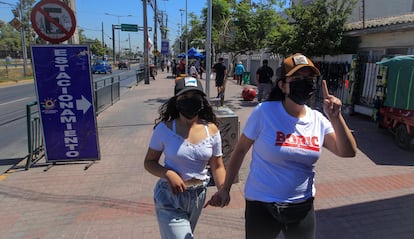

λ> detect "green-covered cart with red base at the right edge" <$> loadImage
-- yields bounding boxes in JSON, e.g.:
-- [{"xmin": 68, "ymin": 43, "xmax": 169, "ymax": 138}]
[{"xmin": 377, "ymin": 55, "xmax": 414, "ymax": 149}]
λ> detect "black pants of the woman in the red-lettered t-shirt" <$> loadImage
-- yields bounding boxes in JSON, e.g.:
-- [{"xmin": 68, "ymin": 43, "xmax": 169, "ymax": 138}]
[{"xmin": 245, "ymin": 200, "xmax": 315, "ymax": 239}]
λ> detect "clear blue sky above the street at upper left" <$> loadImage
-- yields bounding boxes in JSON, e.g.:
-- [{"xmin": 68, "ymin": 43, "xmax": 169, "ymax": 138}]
[{"xmin": 0, "ymin": 0, "xmax": 207, "ymax": 51}]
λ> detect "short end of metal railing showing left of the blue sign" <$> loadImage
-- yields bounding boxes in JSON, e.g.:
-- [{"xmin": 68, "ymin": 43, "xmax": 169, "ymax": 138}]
[{"xmin": 25, "ymin": 101, "xmax": 45, "ymax": 170}]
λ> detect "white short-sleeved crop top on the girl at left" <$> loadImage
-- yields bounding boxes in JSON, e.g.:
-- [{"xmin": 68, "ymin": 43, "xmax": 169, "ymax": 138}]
[{"xmin": 149, "ymin": 122, "xmax": 222, "ymax": 181}]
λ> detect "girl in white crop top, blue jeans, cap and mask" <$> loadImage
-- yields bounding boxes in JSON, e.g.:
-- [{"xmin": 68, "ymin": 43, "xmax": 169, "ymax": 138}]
[{"xmin": 144, "ymin": 77, "xmax": 225, "ymax": 239}]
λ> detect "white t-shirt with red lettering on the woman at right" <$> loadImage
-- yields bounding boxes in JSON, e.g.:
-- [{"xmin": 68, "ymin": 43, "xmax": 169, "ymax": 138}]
[{"xmin": 243, "ymin": 101, "xmax": 333, "ymax": 203}]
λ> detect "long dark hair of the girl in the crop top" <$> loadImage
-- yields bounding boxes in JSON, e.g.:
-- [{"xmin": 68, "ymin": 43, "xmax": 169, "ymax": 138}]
[{"xmin": 154, "ymin": 93, "xmax": 218, "ymax": 128}]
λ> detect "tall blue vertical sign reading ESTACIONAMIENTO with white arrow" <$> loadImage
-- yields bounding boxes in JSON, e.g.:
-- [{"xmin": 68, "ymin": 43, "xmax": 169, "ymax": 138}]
[{"xmin": 32, "ymin": 45, "xmax": 100, "ymax": 162}]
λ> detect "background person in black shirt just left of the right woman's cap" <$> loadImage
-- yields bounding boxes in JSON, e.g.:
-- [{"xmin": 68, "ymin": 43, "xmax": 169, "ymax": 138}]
[{"xmin": 256, "ymin": 60, "xmax": 273, "ymax": 102}]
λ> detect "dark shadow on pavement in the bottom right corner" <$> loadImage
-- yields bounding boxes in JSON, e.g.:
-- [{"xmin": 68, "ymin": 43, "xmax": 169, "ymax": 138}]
[{"xmin": 316, "ymin": 194, "xmax": 414, "ymax": 239}]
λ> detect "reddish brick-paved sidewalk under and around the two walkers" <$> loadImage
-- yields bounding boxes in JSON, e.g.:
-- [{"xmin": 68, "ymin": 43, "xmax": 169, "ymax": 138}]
[{"xmin": 0, "ymin": 71, "xmax": 414, "ymax": 239}]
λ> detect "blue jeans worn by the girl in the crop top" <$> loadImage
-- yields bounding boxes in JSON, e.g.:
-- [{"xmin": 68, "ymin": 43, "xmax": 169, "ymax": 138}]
[{"xmin": 154, "ymin": 179, "xmax": 208, "ymax": 239}]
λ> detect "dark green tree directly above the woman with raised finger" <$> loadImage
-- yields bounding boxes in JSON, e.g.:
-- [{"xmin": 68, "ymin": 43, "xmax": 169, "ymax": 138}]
[{"xmin": 274, "ymin": 0, "xmax": 357, "ymax": 56}]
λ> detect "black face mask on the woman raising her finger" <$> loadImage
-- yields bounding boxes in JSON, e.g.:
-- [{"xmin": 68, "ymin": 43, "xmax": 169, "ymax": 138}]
[{"xmin": 288, "ymin": 78, "xmax": 316, "ymax": 105}]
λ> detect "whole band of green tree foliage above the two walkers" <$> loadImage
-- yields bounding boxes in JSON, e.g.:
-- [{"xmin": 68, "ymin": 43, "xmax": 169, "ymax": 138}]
[{"xmin": 183, "ymin": 0, "xmax": 359, "ymax": 56}]
